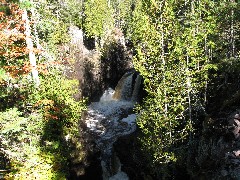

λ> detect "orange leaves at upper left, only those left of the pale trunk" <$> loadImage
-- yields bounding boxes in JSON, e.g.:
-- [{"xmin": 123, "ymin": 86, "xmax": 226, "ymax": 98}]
[{"xmin": 0, "ymin": 1, "xmax": 27, "ymax": 65}]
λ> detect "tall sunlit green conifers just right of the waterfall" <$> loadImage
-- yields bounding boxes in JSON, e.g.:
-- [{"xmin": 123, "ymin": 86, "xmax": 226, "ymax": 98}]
[{"xmin": 129, "ymin": 0, "xmax": 216, "ymax": 166}]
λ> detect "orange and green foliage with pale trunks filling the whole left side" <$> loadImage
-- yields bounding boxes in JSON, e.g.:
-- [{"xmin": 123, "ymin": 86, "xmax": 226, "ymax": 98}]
[{"xmin": 0, "ymin": 0, "xmax": 88, "ymax": 179}]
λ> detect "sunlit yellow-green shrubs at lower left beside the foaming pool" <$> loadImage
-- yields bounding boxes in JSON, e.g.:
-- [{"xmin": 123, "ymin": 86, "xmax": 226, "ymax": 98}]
[{"xmin": 0, "ymin": 73, "xmax": 85, "ymax": 179}]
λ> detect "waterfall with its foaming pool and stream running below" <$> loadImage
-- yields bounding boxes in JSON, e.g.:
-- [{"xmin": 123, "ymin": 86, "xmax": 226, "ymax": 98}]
[{"xmin": 85, "ymin": 72, "xmax": 141, "ymax": 180}]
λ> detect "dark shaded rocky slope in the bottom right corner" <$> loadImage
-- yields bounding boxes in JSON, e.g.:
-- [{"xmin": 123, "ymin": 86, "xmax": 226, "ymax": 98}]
[{"xmin": 187, "ymin": 114, "xmax": 240, "ymax": 180}]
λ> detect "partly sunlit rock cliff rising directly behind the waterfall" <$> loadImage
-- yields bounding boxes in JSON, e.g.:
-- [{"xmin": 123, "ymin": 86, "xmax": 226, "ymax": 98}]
[{"xmin": 62, "ymin": 26, "xmax": 131, "ymax": 101}]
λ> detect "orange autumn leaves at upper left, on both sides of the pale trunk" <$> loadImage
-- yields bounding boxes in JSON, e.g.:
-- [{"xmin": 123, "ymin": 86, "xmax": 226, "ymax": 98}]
[{"xmin": 0, "ymin": 1, "xmax": 47, "ymax": 78}]
